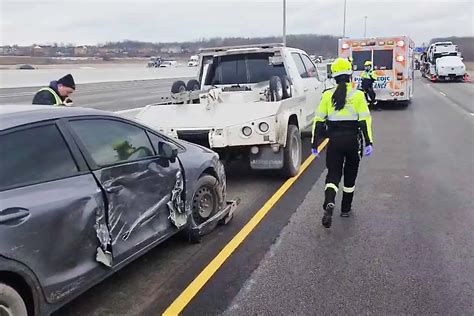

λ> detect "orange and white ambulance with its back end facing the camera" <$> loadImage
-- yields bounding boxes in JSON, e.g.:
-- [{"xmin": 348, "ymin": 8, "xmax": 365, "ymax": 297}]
[{"xmin": 339, "ymin": 36, "xmax": 415, "ymax": 103}]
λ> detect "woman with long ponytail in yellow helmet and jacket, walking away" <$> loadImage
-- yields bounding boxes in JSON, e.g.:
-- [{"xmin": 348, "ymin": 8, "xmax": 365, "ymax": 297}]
[{"xmin": 311, "ymin": 58, "xmax": 373, "ymax": 228}]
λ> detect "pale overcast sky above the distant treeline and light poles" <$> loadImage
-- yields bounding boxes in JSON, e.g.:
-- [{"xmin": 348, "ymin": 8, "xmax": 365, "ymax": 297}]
[{"xmin": 0, "ymin": 0, "xmax": 474, "ymax": 45}]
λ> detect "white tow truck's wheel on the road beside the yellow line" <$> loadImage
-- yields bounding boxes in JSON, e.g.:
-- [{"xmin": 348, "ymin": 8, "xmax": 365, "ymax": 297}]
[{"xmin": 282, "ymin": 125, "xmax": 302, "ymax": 177}]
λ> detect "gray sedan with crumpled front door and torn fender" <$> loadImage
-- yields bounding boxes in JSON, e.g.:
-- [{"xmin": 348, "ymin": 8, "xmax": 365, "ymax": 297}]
[{"xmin": 0, "ymin": 105, "xmax": 238, "ymax": 315}]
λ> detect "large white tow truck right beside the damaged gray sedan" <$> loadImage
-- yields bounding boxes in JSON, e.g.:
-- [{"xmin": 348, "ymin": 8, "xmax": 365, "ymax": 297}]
[{"xmin": 135, "ymin": 44, "xmax": 325, "ymax": 177}]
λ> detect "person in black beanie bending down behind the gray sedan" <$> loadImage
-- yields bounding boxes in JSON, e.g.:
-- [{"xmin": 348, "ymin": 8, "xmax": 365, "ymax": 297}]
[{"xmin": 33, "ymin": 74, "xmax": 76, "ymax": 105}]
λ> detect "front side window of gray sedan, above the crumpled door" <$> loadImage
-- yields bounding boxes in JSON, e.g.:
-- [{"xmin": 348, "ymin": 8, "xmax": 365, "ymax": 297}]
[{"xmin": 70, "ymin": 119, "xmax": 154, "ymax": 167}]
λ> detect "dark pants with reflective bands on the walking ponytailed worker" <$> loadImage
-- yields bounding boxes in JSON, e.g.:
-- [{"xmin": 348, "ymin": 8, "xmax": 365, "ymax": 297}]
[{"xmin": 323, "ymin": 134, "xmax": 360, "ymax": 212}]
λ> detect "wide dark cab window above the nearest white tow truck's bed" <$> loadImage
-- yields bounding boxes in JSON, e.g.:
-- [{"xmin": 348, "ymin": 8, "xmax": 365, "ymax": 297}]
[{"xmin": 204, "ymin": 53, "xmax": 286, "ymax": 85}]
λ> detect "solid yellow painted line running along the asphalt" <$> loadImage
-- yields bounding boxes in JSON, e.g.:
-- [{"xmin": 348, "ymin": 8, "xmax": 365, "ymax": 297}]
[{"xmin": 163, "ymin": 139, "xmax": 328, "ymax": 316}]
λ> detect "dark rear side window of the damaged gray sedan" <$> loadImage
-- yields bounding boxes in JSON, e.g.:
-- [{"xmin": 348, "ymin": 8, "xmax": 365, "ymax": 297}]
[{"xmin": 0, "ymin": 124, "xmax": 78, "ymax": 191}]
